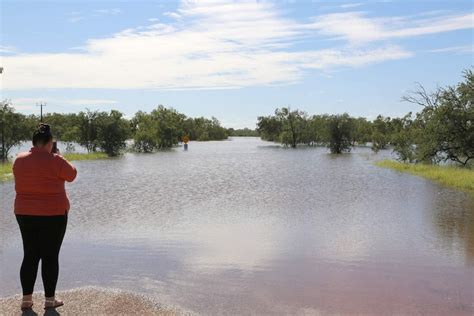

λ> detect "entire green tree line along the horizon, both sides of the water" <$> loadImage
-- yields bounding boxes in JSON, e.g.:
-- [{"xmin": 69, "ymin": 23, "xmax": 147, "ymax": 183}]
[{"xmin": 0, "ymin": 70, "xmax": 474, "ymax": 166}]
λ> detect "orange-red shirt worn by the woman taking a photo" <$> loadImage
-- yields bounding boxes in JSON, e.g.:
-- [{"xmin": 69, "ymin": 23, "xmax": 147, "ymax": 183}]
[{"xmin": 13, "ymin": 147, "xmax": 77, "ymax": 216}]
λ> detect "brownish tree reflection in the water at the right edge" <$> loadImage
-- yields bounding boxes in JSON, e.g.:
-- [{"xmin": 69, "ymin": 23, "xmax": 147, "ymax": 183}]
[{"xmin": 433, "ymin": 191, "xmax": 474, "ymax": 266}]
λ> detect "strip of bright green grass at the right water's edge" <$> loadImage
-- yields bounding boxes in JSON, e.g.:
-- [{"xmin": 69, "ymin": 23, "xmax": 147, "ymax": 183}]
[{"xmin": 375, "ymin": 160, "xmax": 474, "ymax": 194}]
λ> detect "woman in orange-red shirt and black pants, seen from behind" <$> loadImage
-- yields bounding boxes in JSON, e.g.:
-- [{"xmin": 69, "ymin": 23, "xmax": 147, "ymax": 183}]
[{"xmin": 13, "ymin": 124, "xmax": 77, "ymax": 310}]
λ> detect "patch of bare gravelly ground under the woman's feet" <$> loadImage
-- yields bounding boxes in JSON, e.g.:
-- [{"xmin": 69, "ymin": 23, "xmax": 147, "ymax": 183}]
[{"xmin": 0, "ymin": 287, "xmax": 183, "ymax": 316}]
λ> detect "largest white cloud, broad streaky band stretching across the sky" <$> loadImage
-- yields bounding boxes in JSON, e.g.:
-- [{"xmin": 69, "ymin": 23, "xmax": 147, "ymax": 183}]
[{"xmin": 0, "ymin": 1, "xmax": 472, "ymax": 90}]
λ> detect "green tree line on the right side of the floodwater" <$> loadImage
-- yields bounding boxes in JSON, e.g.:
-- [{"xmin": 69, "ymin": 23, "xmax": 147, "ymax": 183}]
[{"xmin": 257, "ymin": 70, "xmax": 474, "ymax": 166}]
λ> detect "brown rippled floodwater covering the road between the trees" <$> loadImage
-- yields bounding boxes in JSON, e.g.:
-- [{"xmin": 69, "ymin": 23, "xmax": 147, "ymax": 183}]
[{"xmin": 0, "ymin": 138, "xmax": 474, "ymax": 315}]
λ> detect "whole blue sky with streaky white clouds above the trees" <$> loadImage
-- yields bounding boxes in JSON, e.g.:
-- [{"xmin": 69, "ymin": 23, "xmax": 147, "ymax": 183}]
[{"xmin": 0, "ymin": 0, "xmax": 474, "ymax": 128}]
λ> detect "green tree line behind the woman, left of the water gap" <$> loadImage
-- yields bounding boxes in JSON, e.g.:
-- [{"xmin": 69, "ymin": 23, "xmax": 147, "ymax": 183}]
[{"xmin": 0, "ymin": 101, "xmax": 233, "ymax": 160}]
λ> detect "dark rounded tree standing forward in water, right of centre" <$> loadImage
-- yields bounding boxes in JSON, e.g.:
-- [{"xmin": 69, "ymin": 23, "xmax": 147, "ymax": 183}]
[{"xmin": 328, "ymin": 113, "xmax": 354, "ymax": 154}]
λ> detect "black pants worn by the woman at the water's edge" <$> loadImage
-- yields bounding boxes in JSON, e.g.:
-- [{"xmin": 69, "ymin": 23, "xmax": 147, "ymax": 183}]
[{"xmin": 16, "ymin": 213, "xmax": 67, "ymax": 297}]
